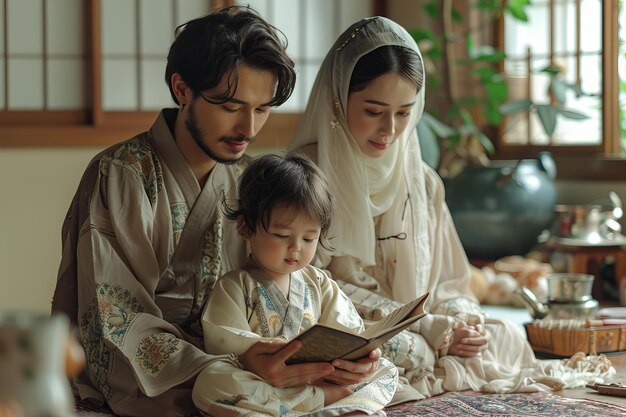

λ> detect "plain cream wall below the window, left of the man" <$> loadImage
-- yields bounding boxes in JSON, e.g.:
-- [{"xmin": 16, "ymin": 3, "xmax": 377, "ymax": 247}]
[{"xmin": 0, "ymin": 145, "xmax": 279, "ymax": 312}]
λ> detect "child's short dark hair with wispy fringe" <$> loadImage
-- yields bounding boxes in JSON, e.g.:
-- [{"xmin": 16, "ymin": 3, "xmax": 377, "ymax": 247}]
[{"xmin": 225, "ymin": 153, "xmax": 333, "ymax": 250}]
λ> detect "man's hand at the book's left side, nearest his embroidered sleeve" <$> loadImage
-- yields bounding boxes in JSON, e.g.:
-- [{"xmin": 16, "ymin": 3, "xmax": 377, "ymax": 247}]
[{"xmin": 239, "ymin": 341, "xmax": 335, "ymax": 388}]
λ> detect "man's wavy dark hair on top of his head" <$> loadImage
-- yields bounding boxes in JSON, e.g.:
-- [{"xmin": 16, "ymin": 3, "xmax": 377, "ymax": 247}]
[{"xmin": 165, "ymin": 6, "xmax": 296, "ymax": 106}]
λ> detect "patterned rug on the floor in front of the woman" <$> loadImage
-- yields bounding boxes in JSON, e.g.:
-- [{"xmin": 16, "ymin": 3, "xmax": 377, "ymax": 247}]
[{"xmin": 385, "ymin": 391, "xmax": 626, "ymax": 417}]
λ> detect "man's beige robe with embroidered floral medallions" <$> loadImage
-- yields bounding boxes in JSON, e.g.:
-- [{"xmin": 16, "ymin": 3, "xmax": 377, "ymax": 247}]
[{"xmin": 52, "ymin": 109, "xmax": 247, "ymax": 416}]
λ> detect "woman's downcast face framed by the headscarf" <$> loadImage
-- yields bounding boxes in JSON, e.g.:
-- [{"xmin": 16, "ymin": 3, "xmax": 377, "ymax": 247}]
[{"xmin": 347, "ymin": 72, "xmax": 417, "ymax": 158}]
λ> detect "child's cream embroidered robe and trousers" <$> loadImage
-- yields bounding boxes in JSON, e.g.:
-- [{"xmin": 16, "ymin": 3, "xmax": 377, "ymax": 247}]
[{"xmin": 193, "ymin": 263, "xmax": 398, "ymax": 417}]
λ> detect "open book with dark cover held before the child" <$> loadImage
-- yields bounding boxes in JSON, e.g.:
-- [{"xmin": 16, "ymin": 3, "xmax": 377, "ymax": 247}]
[{"xmin": 286, "ymin": 293, "xmax": 428, "ymax": 364}]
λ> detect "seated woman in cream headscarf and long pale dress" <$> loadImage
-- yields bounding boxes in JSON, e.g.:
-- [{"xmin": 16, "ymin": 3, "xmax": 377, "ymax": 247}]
[{"xmin": 290, "ymin": 17, "xmax": 608, "ymax": 402}]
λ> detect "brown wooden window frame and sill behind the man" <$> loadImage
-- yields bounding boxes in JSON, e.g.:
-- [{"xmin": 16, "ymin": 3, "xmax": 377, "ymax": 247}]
[{"xmin": 0, "ymin": 0, "xmax": 301, "ymax": 148}]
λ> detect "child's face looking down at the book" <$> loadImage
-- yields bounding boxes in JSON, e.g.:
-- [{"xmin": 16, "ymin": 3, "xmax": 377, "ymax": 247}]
[{"xmin": 244, "ymin": 207, "xmax": 321, "ymax": 281}]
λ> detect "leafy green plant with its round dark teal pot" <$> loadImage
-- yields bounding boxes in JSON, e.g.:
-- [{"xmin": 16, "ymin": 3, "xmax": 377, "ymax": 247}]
[{"xmin": 410, "ymin": 0, "xmax": 586, "ymax": 259}]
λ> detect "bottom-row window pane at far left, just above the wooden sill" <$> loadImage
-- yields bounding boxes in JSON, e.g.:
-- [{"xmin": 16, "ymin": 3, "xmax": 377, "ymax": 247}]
[{"xmin": 8, "ymin": 58, "xmax": 44, "ymax": 110}]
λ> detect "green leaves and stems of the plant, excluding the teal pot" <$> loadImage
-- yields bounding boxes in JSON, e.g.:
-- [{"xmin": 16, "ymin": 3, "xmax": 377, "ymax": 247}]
[{"xmin": 409, "ymin": 0, "xmax": 588, "ymax": 177}]
